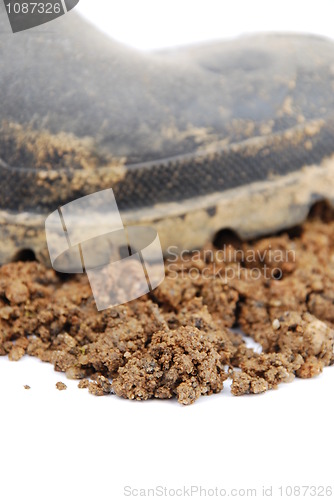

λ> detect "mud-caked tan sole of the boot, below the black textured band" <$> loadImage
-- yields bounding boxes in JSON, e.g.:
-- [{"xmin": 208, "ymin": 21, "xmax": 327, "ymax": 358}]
[{"xmin": 0, "ymin": 152, "xmax": 334, "ymax": 266}]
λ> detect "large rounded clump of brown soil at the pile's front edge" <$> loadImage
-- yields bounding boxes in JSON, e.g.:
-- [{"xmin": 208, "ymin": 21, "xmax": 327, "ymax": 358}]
[{"xmin": 113, "ymin": 326, "xmax": 229, "ymax": 404}]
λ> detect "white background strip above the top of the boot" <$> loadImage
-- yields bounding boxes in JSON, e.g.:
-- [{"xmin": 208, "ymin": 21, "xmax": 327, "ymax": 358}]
[{"xmin": 77, "ymin": 0, "xmax": 334, "ymax": 50}]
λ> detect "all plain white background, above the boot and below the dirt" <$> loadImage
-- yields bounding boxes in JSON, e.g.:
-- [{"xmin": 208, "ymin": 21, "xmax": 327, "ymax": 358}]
[{"xmin": 0, "ymin": 0, "xmax": 334, "ymax": 500}]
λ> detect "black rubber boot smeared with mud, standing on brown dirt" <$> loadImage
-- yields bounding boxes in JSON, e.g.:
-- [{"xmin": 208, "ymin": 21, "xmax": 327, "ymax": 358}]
[{"xmin": 0, "ymin": 3, "xmax": 334, "ymax": 262}]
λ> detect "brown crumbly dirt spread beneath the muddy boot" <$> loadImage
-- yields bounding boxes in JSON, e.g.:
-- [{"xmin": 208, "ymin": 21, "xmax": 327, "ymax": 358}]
[{"xmin": 0, "ymin": 205, "xmax": 334, "ymax": 405}]
